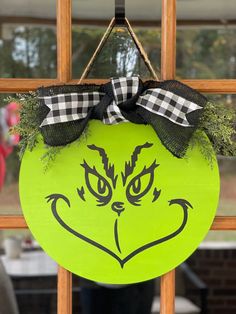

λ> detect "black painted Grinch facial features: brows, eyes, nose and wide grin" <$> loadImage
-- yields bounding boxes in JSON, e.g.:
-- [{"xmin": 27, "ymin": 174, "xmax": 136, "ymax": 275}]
[{"xmin": 46, "ymin": 142, "xmax": 192, "ymax": 267}]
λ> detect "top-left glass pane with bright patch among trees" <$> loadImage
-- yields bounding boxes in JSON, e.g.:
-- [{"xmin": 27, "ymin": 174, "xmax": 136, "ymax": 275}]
[{"xmin": 0, "ymin": 0, "xmax": 57, "ymax": 78}]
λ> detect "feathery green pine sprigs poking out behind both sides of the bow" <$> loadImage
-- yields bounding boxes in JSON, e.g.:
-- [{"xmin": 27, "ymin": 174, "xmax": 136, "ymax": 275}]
[{"xmin": 6, "ymin": 92, "xmax": 236, "ymax": 170}]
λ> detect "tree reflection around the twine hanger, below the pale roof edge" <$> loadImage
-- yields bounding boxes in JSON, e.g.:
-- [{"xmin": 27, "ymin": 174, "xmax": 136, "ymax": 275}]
[{"xmin": 73, "ymin": 27, "xmax": 160, "ymax": 79}]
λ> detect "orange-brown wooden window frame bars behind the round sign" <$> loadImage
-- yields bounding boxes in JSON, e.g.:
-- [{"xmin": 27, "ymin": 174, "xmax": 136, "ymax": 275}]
[{"xmin": 0, "ymin": 0, "xmax": 236, "ymax": 314}]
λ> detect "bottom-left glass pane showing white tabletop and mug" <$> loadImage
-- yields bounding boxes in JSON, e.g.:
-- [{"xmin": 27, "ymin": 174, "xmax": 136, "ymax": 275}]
[{"xmin": 0, "ymin": 229, "xmax": 57, "ymax": 314}]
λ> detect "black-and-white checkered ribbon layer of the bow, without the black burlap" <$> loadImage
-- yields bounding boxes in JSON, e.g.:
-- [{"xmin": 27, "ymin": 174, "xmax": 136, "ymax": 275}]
[{"xmin": 41, "ymin": 77, "xmax": 202, "ymax": 127}]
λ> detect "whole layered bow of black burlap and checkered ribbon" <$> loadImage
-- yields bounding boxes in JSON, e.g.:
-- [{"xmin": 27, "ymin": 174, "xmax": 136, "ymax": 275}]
[{"xmin": 39, "ymin": 77, "xmax": 206, "ymax": 157}]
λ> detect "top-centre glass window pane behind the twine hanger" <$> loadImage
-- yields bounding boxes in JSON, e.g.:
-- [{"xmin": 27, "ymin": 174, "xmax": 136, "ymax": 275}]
[{"xmin": 72, "ymin": 0, "xmax": 161, "ymax": 79}]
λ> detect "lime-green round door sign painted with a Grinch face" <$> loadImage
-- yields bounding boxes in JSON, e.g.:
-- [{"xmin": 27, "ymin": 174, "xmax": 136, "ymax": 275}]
[{"xmin": 20, "ymin": 120, "xmax": 219, "ymax": 284}]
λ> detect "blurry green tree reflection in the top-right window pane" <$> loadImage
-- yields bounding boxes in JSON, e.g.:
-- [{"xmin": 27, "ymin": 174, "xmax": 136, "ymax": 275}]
[{"xmin": 176, "ymin": 28, "xmax": 236, "ymax": 79}]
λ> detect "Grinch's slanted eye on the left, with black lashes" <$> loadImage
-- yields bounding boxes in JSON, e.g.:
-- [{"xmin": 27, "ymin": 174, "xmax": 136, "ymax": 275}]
[{"xmin": 81, "ymin": 161, "xmax": 112, "ymax": 206}]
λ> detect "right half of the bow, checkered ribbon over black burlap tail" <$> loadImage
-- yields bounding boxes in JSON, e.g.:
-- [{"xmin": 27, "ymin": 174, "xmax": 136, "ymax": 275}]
[{"xmin": 137, "ymin": 81, "xmax": 207, "ymax": 158}]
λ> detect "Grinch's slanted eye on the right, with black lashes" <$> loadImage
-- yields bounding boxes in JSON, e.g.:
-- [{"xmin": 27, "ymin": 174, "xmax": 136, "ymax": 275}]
[{"xmin": 126, "ymin": 160, "xmax": 159, "ymax": 206}]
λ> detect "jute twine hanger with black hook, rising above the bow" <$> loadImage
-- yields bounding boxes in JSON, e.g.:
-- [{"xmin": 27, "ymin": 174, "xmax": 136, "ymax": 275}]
[{"xmin": 78, "ymin": 0, "xmax": 159, "ymax": 84}]
